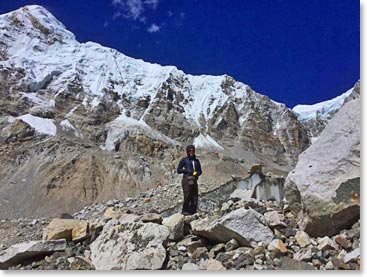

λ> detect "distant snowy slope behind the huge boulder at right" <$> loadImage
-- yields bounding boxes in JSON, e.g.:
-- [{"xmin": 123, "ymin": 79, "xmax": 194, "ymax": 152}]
[{"xmin": 292, "ymin": 88, "xmax": 353, "ymax": 121}]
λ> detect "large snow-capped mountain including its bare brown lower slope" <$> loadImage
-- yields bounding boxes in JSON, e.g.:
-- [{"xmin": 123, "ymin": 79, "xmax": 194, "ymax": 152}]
[{"xmin": 0, "ymin": 5, "xmax": 360, "ymax": 215}]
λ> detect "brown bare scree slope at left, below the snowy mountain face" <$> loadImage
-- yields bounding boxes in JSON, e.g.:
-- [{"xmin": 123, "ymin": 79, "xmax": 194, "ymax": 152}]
[{"xmin": 0, "ymin": 138, "xmax": 178, "ymax": 218}]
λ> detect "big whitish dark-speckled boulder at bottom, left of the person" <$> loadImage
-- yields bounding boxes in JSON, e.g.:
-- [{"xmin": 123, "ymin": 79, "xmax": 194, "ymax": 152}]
[{"xmin": 90, "ymin": 220, "xmax": 170, "ymax": 270}]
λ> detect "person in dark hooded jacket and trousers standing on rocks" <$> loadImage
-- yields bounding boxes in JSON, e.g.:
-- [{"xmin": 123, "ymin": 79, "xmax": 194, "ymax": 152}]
[{"xmin": 177, "ymin": 145, "xmax": 202, "ymax": 215}]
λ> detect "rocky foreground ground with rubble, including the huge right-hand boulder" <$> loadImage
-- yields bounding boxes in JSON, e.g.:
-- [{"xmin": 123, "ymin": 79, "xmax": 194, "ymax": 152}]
[{"xmin": 0, "ymin": 92, "xmax": 361, "ymax": 270}]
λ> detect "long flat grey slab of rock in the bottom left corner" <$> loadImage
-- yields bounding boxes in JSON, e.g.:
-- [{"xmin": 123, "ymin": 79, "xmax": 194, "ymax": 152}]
[{"xmin": 0, "ymin": 239, "xmax": 66, "ymax": 269}]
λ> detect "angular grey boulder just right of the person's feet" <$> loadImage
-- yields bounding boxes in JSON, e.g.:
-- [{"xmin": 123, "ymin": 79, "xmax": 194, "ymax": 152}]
[{"xmin": 191, "ymin": 208, "xmax": 274, "ymax": 246}]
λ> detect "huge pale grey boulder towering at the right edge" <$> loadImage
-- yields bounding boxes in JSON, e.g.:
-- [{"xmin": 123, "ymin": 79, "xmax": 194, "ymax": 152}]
[{"xmin": 285, "ymin": 98, "xmax": 361, "ymax": 237}]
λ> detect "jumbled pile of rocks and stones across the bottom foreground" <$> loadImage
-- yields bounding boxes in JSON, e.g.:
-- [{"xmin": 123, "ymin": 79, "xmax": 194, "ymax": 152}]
[{"xmin": 0, "ymin": 193, "xmax": 360, "ymax": 270}]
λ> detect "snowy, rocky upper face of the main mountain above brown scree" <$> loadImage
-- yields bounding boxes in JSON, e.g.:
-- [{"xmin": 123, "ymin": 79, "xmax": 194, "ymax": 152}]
[{"xmin": 0, "ymin": 5, "xmax": 308, "ymax": 167}]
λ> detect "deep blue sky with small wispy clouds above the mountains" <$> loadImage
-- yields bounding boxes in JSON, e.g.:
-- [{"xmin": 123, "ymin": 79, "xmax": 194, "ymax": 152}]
[{"xmin": 0, "ymin": 0, "xmax": 360, "ymax": 108}]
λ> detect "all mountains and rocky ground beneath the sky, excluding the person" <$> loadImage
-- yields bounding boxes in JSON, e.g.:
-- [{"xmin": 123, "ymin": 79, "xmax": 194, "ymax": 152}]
[{"xmin": 0, "ymin": 3, "xmax": 361, "ymax": 270}]
